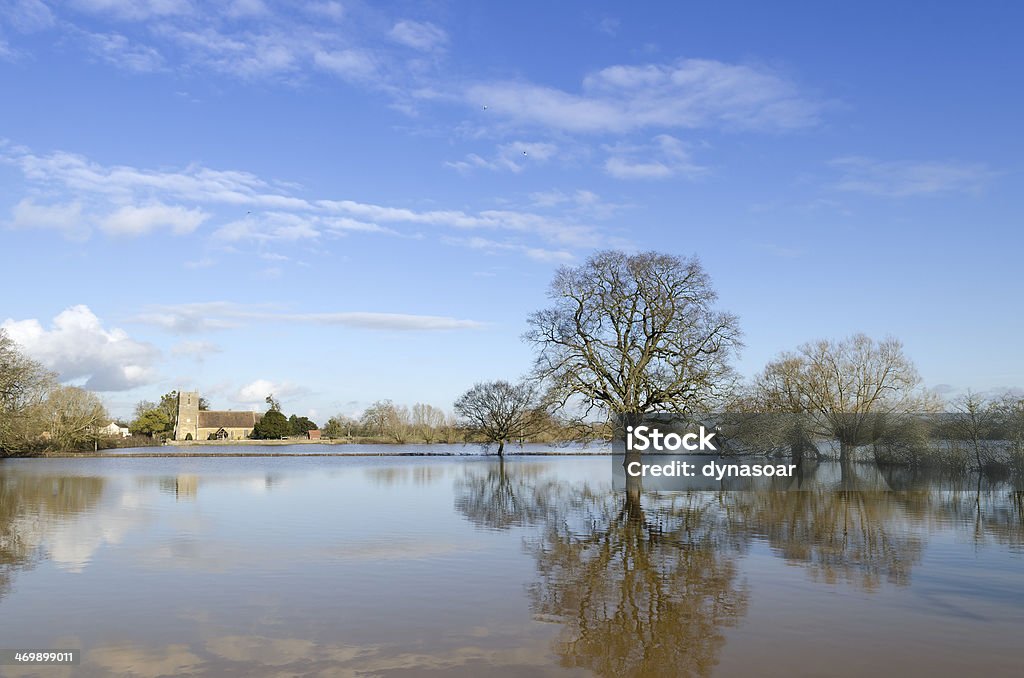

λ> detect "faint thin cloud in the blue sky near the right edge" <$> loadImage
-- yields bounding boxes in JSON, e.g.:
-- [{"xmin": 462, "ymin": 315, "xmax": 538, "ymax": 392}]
[{"xmin": 829, "ymin": 156, "xmax": 996, "ymax": 198}]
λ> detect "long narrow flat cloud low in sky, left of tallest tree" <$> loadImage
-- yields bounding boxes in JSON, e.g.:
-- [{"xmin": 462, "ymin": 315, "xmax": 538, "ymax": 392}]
[{"xmin": 135, "ymin": 301, "xmax": 483, "ymax": 334}]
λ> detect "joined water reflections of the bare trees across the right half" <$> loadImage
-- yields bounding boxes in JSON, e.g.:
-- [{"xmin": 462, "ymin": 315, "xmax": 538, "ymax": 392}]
[{"xmin": 455, "ymin": 462, "xmax": 1024, "ymax": 676}]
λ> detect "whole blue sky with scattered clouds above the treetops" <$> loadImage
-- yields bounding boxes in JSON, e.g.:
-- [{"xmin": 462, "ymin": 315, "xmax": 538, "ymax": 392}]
[{"xmin": 0, "ymin": 0, "xmax": 1024, "ymax": 420}]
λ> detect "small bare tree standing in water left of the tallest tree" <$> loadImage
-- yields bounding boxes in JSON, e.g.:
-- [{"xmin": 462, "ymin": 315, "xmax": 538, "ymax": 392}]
[{"xmin": 455, "ymin": 381, "xmax": 550, "ymax": 457}]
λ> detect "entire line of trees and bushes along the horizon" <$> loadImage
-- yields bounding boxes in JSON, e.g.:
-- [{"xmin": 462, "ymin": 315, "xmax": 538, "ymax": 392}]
[{"xmin": 0, "ymin": 251, "xmax": 1024, "ymax": 470}]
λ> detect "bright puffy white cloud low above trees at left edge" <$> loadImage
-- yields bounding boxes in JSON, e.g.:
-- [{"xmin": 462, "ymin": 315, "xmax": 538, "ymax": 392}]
[{"xmin": 0, "ymin": 304, "xmax": 159, "ymax": 391}]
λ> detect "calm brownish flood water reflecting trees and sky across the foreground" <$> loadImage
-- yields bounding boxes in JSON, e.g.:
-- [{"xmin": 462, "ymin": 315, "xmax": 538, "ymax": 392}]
[{"xmin": 0, "ymin": 450, "xmax": 1024, "ymax": 676}]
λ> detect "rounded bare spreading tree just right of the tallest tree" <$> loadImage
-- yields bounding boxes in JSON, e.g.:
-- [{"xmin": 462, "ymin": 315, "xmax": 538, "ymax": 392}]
[{"xmin": 757, "ymin": 334, "xmax": 935, "ymax": 462}]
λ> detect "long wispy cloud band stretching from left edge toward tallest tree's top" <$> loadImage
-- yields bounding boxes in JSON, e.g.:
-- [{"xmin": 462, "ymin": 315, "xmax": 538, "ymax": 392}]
[{"xmin": 0, "ymin": 142, "xmax": 608, "ymax": 256}]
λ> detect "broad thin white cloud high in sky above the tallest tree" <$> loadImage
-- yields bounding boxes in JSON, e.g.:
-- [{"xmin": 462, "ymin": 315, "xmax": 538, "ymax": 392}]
[{"xmin": 464, "ymin": 58, "xmax": 821, "ymax": 133}]
